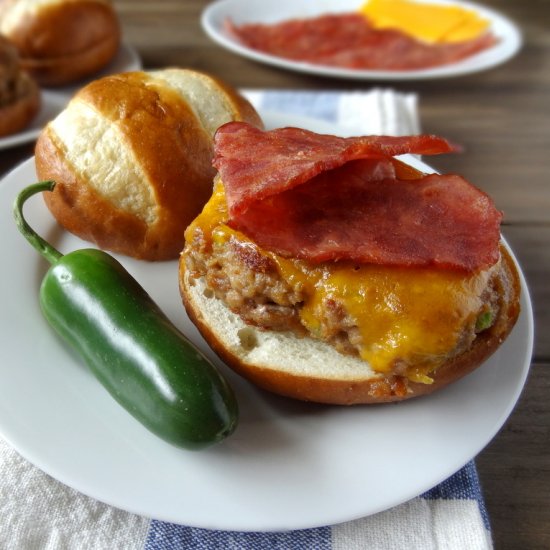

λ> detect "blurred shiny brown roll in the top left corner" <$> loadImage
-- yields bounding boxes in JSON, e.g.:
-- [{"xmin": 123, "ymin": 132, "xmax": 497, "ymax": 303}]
[{"xmin": 0, "ymin": 0, "xmax": 120, "ymax": 86}]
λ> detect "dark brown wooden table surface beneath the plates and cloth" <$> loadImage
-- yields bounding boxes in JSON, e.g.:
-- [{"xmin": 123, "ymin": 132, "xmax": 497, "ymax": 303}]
[{"xmin": 0, "ymin": 0, "xmax": 550, "ymax": 549}]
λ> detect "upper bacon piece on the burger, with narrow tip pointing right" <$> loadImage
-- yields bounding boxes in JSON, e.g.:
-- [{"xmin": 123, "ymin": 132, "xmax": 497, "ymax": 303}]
[{"xmin": 214, "ymin": 122, "xmax": 456, "ymax": 216}]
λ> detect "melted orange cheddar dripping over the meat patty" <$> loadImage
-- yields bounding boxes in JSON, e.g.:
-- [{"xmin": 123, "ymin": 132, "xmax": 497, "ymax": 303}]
[{"xmin": 186, "ymin": 182, "xmax": 498, "ymax": 384}]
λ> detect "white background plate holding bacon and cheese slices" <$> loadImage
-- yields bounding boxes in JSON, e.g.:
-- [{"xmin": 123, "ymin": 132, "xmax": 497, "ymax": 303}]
[{"xmin": 201, "ymin": 0, "xmax": 522, "ymax": 80}]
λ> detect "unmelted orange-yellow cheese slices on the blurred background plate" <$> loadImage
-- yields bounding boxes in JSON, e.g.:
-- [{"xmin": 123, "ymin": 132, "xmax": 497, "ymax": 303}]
[{"xmin": 359, "ymin": 0, "xmax": 489, "ymax": 43}]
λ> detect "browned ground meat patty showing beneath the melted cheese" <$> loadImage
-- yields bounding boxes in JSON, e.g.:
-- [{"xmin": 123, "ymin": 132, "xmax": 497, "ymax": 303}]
[{"xmin": 185, "ymin": 226, "xmax": 499, "ymax": 364}]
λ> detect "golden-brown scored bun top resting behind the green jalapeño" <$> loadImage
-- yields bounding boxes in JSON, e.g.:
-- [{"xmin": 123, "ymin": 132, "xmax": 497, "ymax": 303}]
[{"xmin": 35, "ymin": 68, "xmax": 262, "ymax": 260}]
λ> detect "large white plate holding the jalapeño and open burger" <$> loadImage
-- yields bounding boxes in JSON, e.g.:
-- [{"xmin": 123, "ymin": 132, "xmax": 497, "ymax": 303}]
[{"xmin": 0, "ymin": 113, "xmax": 533, "ymax": 531}]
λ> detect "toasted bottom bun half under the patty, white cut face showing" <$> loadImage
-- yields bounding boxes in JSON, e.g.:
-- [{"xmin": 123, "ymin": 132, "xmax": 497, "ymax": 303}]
[{"xmin": 179, "ymin": 247, "xmax": 520, "ymax": 405}]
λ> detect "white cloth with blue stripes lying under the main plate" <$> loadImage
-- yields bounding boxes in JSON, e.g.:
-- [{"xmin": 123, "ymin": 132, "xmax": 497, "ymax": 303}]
[{"xmin": 0, "ymin": 89, "xmax": 492, "ymax": 550}]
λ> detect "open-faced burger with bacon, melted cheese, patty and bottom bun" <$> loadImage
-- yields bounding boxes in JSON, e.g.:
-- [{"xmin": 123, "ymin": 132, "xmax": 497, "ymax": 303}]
[{"xmin": 179, "ymin": 122, "xmax": 520, "ymax": 405}]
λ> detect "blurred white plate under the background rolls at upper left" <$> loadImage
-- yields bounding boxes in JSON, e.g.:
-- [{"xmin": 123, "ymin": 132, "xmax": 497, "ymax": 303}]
[{"xmin": 0, "ymin": 44, "xmax": 141, "ymax": 150}]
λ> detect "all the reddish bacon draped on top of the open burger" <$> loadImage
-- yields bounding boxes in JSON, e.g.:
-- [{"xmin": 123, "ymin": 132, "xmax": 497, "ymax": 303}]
[{"xmin": 214, "ymin": 122, "xmax": 502, "ymax": 272}]
